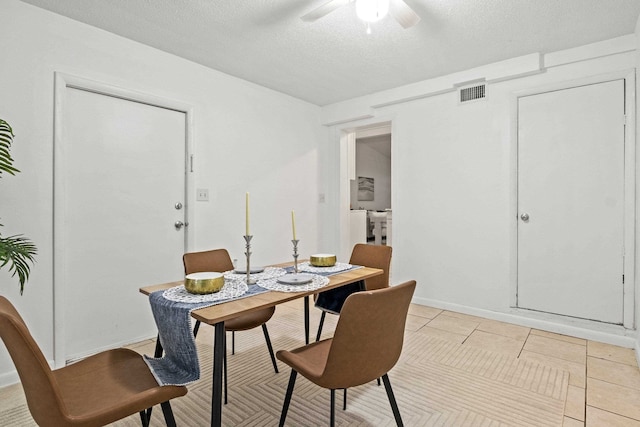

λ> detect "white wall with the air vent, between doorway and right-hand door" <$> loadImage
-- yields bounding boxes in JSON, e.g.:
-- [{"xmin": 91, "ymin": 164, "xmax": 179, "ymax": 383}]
[{"xmin": 323, "ymin": 35, "xmax": 637, "ymax": 345}]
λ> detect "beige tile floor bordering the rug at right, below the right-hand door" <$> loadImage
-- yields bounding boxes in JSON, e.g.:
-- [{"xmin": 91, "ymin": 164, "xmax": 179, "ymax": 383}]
[{"xmin": 407, "ymin": 304, "xmax": 640, "ymax": 427}]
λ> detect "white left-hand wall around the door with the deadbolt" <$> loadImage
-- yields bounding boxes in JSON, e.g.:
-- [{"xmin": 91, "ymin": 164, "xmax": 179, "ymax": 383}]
[{"xmin": 0, "ymin": 0, "xmax": 328, "ymax": 385}]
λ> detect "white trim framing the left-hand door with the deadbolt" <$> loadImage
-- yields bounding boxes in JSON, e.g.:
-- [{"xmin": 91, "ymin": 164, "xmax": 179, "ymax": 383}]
[{"xmin": 53, "ymin": 71, "xmax": 195, "ymax": 368}]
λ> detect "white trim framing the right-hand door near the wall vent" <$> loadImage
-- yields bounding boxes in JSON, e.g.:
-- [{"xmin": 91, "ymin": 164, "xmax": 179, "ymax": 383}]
[{"xmin": 509, "ymin": 69, "xmax": 637, "ymax": 329}]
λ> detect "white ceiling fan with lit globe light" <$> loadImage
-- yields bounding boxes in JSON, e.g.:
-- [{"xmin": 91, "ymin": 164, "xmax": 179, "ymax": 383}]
[{"xmin": 300, "ymin": 0, "xmax": 420, "ymax": 33}]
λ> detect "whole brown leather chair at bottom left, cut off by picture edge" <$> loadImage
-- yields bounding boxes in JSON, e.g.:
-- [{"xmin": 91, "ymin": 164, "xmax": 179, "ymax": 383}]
[{"xmin": 0, "ymin": 297, "xmax": 187, "ymax": 427}]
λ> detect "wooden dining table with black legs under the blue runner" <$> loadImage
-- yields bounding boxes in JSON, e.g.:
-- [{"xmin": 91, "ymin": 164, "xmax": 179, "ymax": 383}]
[{"xmin": 140, "ymin": 263, "xmax": 384, "ymax": 427}]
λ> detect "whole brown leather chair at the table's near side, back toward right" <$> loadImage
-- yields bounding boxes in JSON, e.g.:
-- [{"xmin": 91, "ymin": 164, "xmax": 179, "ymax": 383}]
[{"xmin": 276, "ymin": 280, "xmax": 416, "ymax": 426}]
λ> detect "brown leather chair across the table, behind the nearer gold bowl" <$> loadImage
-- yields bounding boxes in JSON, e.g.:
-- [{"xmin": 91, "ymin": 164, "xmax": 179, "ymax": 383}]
[{"xmin": 182, "ymin": 249, "xmax": 278, "ymax": 403}]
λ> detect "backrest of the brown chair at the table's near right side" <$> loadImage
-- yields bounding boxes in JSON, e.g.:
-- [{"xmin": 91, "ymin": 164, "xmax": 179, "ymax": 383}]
[{"xmin": 319, "ymin": 280, "xmax": 416, "ymax": 389}]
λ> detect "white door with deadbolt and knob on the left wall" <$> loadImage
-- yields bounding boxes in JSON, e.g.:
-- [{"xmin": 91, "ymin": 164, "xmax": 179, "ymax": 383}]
[{"xmin": 56, "ymin": 82, "xmax": 186, "ymax": 360}]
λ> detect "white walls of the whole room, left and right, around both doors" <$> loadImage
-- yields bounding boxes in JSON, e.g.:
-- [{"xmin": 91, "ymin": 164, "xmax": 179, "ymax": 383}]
[{"xmin": 0, "ymin": 0, "xmax": 640, "ymax": 392}]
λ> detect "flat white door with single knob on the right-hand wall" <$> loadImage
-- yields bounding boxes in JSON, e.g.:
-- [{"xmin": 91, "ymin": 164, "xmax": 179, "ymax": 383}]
[{"xmin": 517, "ymin": 79, "xmax": 625, "ymax": 324}]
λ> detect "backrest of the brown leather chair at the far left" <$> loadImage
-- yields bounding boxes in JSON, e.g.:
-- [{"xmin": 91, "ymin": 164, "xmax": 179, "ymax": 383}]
[{"xmin": 0, "ymin": 296, "xmax": 67, "ymax": 425}]
